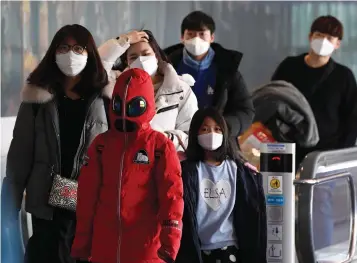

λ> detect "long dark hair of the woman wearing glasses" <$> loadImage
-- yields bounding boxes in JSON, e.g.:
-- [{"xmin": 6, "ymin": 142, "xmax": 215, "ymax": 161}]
[{"xmin": 27, "ymin": 24, "xmax": 108, "ymax": 96}]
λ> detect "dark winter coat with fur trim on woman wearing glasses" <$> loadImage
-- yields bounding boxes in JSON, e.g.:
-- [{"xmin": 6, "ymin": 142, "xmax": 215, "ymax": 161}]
[{"xmin": 1, "ymin": 82, "xmax": 112, "ymax": 220}]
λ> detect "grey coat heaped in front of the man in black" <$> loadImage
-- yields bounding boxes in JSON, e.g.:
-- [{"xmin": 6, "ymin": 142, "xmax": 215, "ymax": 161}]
[{"xmin": 252, "ymin": 80, "xmax": 320, "ymax": 147}]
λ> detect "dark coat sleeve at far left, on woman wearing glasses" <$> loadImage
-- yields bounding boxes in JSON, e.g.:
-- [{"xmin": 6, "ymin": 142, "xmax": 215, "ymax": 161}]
[{"xmin": 1, "ymin": 103, "xmax": 35, "ymax": 216}]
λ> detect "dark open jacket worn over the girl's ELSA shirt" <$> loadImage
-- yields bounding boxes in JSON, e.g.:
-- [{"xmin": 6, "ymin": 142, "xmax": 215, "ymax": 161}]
[{"xmin": 175, "ymin": 161, "xmax": 267, "ymax": 263}]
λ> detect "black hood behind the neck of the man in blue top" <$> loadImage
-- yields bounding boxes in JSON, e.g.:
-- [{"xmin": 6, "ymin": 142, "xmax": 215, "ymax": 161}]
[{"xmin": 164, "ymin": 43, "xmax": 243, "ymax": 74}]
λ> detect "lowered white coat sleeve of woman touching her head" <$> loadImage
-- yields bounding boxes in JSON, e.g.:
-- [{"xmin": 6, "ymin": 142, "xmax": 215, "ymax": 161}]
[{"xmin": 168, "ymin": 83, "xmax": 198, "ymax": 150}]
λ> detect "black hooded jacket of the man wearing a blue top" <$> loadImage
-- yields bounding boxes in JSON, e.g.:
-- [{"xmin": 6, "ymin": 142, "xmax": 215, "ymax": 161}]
[{"xmin": 165, "ymin": 43, "xmax": 254, "ymax": 137}]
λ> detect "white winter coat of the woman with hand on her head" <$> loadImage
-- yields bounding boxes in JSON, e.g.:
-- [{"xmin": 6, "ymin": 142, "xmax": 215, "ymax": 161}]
[{"xmin": 98, "ymin": 39, "xmax": 198, "ymax": 150}]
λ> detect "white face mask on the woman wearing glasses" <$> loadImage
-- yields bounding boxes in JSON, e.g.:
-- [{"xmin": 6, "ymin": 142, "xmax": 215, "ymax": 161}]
[{"xmin": 56, "ymin": 50, "xmax": 88, "ymax": 77}]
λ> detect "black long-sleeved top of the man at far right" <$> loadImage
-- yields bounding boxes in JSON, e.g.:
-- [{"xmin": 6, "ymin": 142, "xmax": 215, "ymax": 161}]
[{"xmin": 272, "ymin": 54, "xmax": 357, "ymax": 153}]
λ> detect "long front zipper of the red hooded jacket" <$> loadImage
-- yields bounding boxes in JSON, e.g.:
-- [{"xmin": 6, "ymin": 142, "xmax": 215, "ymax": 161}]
[{"xmin": 117, "ymin": 77, "xmax": 131, "ymax": 263}]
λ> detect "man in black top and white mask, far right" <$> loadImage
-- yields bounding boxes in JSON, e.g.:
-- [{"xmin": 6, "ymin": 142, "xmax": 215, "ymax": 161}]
[{"xmin": 272, "ymin": 16, "xmax": 357, "ymax": 165}]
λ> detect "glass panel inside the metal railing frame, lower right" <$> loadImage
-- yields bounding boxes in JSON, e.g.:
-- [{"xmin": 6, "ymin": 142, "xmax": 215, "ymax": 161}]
[{"xmin": 312, "ymin": 167, "xmax": 357, "ymax": 262}]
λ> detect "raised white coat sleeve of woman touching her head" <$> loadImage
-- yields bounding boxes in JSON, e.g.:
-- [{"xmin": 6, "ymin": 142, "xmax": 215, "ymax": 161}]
[{"xmin": 98, "ymin": 39, "xmax": 130, "ymax": 78}]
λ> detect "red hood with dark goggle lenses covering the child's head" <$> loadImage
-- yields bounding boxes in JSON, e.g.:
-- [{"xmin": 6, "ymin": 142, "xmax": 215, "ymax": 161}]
[{"xmin": 109, "ymin": 68, "xmax": 155, "ymax": 132}]
